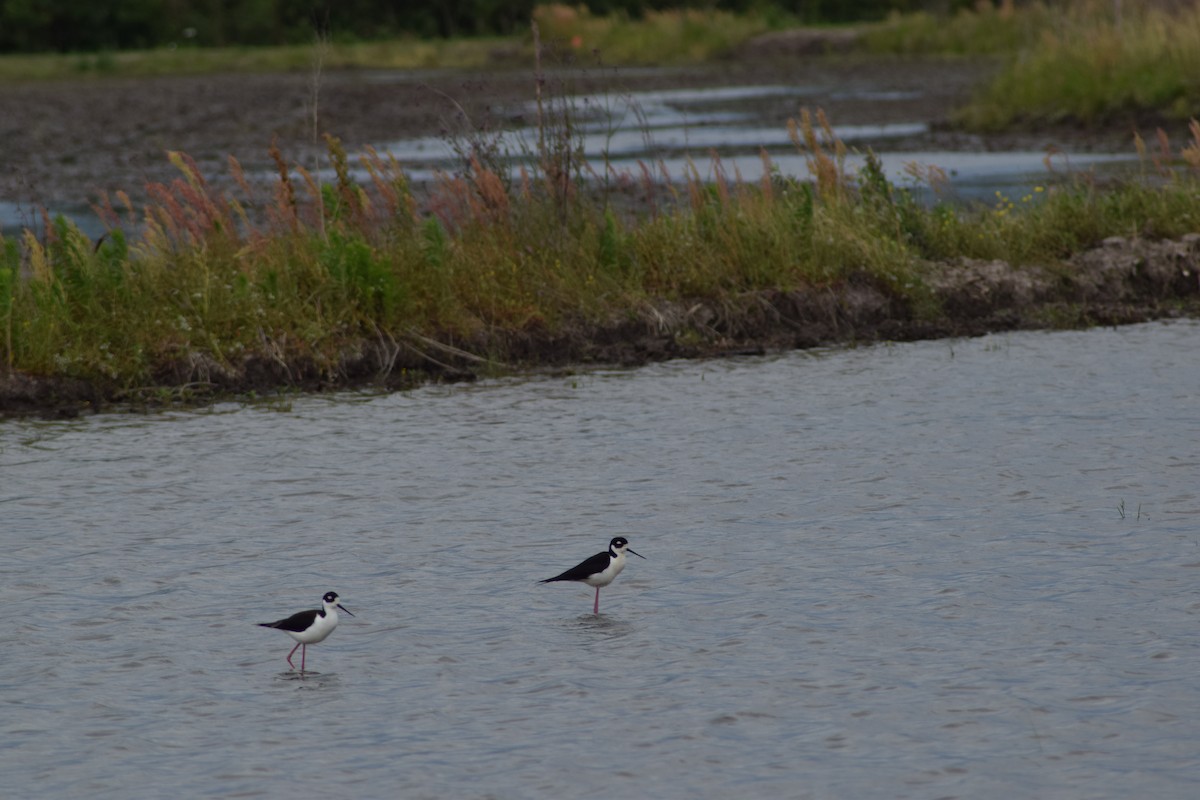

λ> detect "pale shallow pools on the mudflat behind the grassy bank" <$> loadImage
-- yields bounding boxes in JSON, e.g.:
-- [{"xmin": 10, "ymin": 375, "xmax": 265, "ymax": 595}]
[{"xmin": 367, "ymin": 84, "xmax": 1136, "ymax": 201}]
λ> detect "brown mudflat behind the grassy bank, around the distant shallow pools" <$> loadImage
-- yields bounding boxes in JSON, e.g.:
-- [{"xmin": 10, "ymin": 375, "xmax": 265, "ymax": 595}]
[{"xmin": 0, "ymin": 53, "xmax": 1133, "ymax": 223}]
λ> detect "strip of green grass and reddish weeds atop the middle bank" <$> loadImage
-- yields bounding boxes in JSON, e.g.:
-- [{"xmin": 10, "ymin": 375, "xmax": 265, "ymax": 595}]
[{"xmin": 7, "ymin": 107, "xmax": 1200, "ymax": 392}]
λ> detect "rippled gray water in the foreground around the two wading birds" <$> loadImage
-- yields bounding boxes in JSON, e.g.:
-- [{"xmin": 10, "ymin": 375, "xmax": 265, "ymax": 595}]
[{"xmin": 0, "ymin": 321, "xmax": 1200, "ymax": 800}]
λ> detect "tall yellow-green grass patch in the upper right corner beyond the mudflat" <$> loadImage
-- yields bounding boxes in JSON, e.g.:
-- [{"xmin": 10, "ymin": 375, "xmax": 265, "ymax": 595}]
[{"xmin": 863, "ymin": 0, "xmax": 1200, "ymax": 131}]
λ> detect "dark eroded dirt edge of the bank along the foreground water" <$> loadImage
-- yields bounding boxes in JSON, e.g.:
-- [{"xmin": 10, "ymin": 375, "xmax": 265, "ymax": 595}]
[{"xmin": 0, "ymin": 234, "xmax": 1200, "ymax": 417}]
